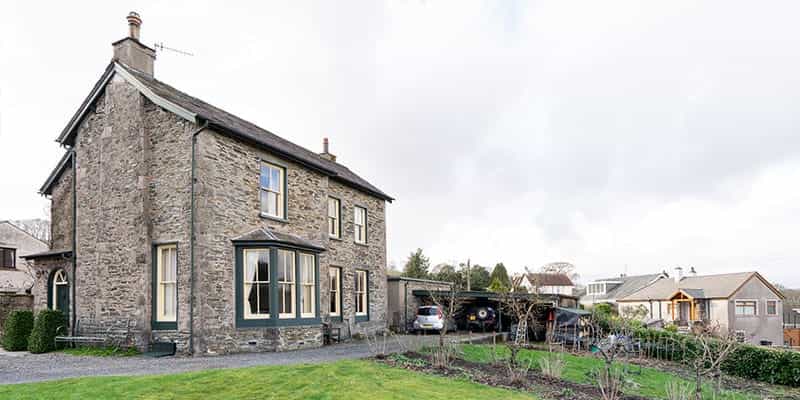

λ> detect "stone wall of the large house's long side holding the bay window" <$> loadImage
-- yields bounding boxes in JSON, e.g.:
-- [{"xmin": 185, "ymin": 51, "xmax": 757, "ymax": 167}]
[{"xmin": 196, "ymin": 132, "xmax": 386, "ymax": 353}]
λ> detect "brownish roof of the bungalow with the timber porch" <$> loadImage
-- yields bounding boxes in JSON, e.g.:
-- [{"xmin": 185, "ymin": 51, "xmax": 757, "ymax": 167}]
[{"xmin": 618, "ymin": 271, "xmax": 779, "ymax": 301}]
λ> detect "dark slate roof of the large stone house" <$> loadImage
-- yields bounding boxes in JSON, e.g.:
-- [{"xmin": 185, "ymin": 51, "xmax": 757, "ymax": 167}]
[{"xmin": 46, "ymin": 62, "xmax": 394, "ymax": 202}]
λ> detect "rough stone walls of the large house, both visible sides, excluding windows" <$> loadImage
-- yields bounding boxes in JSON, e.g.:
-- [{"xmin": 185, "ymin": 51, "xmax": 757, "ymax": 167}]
[{"xmin": 32, "ymin": 66, "xmax": 386, "ymax": 354}]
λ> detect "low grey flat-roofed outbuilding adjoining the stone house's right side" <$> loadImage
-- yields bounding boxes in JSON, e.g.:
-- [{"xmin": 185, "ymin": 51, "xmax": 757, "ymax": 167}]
[{"xmin": 386, "ymin": 276, "xmax": 453, "ymax": 332}]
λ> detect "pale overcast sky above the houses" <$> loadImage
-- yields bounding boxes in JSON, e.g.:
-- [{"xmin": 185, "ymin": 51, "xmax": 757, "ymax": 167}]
[{"xmin": 0, "ymin": 0, "xmax": 800, "ymax": 287}]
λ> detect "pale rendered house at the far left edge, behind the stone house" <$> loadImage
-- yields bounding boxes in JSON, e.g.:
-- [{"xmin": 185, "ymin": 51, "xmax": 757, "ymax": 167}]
[{"xmin": 0, "ymin": 221, "xmax": 48, "ymax": 293}]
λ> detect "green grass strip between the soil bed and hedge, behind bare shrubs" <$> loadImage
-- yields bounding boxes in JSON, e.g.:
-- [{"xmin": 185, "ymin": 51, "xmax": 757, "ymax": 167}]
[{"xmin": 462, "ymin": 345, "xmax": 761, "ymax": 400}]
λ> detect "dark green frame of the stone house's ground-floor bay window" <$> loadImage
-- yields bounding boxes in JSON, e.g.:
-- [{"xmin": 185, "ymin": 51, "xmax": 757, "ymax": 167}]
[{"xmin": 234, "ymin": 243, "xmax": 321, "ymax": 328}]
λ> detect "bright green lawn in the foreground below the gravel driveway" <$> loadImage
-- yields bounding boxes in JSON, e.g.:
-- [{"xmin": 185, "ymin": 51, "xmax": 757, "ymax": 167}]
[{"xmin": 0, "ymin": 360, "xmax": 533, "ymax": 400}]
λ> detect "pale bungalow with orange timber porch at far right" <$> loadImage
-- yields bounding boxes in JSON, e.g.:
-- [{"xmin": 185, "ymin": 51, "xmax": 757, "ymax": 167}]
[{"xmin": 617, "ymin": 268, "xmax": 784, "ymax": 345}]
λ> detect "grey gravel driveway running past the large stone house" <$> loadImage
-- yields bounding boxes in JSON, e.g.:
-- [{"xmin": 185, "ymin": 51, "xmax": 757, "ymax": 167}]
[{"xmin": 0, "ymin": 334, "xmax": 500, "ymax": 384}]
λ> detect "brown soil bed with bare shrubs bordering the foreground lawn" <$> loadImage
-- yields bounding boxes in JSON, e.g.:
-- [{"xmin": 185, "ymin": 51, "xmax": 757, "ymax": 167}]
[{"xmin": 376, "ymin": 352, "xmax": 647, "ymax": 400}]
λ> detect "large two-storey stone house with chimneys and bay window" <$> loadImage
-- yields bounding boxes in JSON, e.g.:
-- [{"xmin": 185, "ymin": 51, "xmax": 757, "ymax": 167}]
[{"xmin": 22, "ymin": 13, "xmax": 393, "ymax": 354}]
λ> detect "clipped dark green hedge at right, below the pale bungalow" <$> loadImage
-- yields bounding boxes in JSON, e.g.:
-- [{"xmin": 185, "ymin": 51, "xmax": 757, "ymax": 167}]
[{"xmin": 634, "ymin": 328, "xmax": 800, "ymax": 387}]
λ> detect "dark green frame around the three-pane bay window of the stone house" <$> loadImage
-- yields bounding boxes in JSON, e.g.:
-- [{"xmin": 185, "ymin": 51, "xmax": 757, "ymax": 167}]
[{"xmin": 234, "ymin": 241, "xmax": 321, "ymax": 329}]
